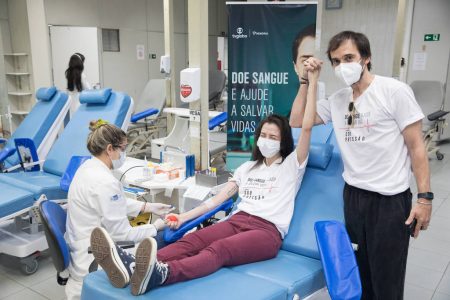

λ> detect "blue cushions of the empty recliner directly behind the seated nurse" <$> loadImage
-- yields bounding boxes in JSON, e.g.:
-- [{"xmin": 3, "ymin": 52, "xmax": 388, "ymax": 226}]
[{"xmin": 0, "ymin": 89, "xmax": 132, "ymax": 203}]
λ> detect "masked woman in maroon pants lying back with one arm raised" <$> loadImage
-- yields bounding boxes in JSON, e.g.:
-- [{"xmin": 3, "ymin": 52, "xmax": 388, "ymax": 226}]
[{"xmin": 91, "ymin": 60, "xmax": 320, "ymax": 295}]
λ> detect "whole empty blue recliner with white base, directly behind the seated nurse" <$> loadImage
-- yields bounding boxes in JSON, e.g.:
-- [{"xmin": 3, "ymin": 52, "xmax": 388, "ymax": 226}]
[{"xmin": 0, "ymin": 89, "xmax": 133, "ymax": 274}]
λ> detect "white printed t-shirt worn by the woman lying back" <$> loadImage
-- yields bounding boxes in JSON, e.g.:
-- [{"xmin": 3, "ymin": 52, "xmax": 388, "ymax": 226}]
[{"xmin": 231, "ymin": 150, "xmax": 308, "ymax": 238}]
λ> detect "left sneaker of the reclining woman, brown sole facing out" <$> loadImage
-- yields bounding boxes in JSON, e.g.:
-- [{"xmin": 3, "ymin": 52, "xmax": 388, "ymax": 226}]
[{"xmin": 91, "ymin": 227, "xmax": 135, "ymax": 288}]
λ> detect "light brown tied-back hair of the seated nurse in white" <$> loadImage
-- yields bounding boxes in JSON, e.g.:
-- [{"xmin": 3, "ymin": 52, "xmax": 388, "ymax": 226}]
[{"xmin": 87, "ymin": 120, "xmax": 127, "ymax": 156}]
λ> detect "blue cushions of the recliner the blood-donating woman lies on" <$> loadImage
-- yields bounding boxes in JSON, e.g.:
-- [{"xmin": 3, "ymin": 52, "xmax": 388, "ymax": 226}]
[{"xmin": 82, "ymin": 124, "xmax": 344, "ymax": 300}]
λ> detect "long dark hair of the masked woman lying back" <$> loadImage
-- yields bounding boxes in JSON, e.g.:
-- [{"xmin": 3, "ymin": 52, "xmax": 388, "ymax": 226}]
[{"xmin": 252, "ymin": 115, "xmax": 294, "ymax": 164}]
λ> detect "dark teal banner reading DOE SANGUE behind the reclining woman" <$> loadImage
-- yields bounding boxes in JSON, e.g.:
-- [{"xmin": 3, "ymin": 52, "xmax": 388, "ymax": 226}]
[{"xmin": 227, "ymin": 2, "xmax": 317, "ymax": 170}]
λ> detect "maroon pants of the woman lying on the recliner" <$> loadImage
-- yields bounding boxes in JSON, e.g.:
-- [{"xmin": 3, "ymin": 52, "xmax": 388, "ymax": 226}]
[{"xmin": 158, "ymin": 212, "xmax": 282, "ymax": 284}]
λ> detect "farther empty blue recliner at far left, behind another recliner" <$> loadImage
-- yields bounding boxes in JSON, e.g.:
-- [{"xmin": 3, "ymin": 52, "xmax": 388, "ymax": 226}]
[{"xmin": 0, "ymin": 87, "xmax": 70, "ymax": 172}]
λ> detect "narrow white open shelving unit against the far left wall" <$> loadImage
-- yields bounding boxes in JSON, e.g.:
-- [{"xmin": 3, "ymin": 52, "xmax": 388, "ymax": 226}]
[{"xmin": 4, "ymin": 53, "xmax": 33, "ymax": 133}]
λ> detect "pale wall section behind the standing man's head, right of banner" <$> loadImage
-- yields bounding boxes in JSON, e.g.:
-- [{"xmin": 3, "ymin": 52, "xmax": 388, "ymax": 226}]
[{"xmin": 319, "ymin": 0, "xmax": 398, "ymax": 95}]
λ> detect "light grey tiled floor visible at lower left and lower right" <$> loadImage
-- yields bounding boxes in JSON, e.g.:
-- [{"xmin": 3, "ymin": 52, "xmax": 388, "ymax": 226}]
[{"xmin": 0, "ymin": 143, "xmax": 450, "ymax": 300}]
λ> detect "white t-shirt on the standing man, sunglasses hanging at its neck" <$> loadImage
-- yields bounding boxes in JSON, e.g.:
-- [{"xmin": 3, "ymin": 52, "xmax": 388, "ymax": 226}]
[{"xmin": 317, "ymin": 76, "xmax": 424, "ymax": 195}]
